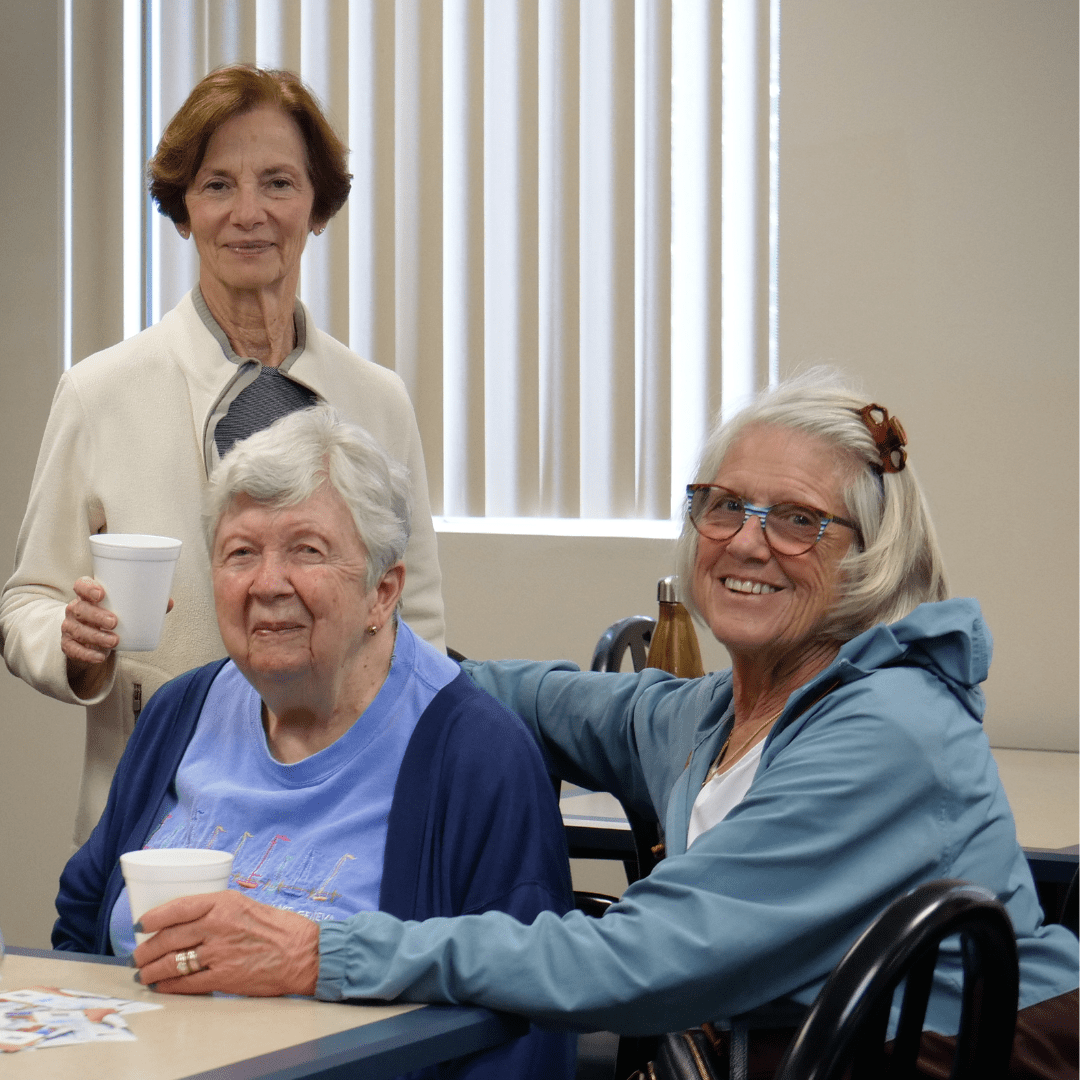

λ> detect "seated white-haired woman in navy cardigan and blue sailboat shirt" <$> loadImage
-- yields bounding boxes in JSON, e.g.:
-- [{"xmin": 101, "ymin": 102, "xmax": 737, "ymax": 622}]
[{"xmin": 53, "ymin": 406, "xmax": 572, "ymax": 1077}]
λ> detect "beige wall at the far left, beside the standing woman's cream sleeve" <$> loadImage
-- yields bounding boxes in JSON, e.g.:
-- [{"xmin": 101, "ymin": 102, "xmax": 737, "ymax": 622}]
[{"xmin": 0, "ymin": 0, "xmax": 83, "ymax": 945}]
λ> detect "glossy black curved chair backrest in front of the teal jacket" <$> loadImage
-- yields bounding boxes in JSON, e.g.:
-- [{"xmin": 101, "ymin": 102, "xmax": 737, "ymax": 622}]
[{"xmin": 777, "ymin": 880, "xmax": 1020, "ymax": 1080}]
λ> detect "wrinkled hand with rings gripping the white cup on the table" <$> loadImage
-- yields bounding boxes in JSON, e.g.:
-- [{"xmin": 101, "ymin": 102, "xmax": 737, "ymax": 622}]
[{"xmin": 133, "ymin": 891, "xmax": 319, "ymax": 997}]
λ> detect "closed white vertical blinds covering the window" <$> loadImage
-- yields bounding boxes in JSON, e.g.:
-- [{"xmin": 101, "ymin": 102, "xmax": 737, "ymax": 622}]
[{"xmin": 69, "ymin": 0, "xmax": 769, "ymax": 526}]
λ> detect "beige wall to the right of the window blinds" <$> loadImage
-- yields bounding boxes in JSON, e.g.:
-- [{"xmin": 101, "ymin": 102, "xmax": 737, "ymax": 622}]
[{"xmin": 779, "ymin": 0, "xmax": 1080, "ymax": 751}]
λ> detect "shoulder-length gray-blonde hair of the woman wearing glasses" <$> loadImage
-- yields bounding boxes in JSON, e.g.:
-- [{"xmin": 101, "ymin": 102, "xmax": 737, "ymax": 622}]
[{"xmin": 676, "ymin": 368, "xmax": 948, "ymax": 642}]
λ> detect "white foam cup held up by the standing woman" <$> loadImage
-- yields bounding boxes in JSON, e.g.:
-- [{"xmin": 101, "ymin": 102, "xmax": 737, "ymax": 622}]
[{"xmin": 90, "ymin": 532, "xmax": 183, "ymax": 652}]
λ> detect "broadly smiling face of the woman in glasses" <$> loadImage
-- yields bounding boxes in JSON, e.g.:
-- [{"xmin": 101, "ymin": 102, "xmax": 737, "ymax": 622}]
[{"xmin": 693, "ymin": 426, "xmax": 852, "ymax": 662}]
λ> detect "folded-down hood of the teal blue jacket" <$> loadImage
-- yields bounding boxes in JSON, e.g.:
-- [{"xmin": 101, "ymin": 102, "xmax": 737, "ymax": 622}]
[{"xmin": 834, "ymin": 597, "xmax": 994, "ymax": 720}]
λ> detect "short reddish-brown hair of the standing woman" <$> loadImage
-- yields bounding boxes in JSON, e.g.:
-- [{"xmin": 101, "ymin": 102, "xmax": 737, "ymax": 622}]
[{"xmin": 147, "ymin": 64, "xmax": 352, "ymax": 225}]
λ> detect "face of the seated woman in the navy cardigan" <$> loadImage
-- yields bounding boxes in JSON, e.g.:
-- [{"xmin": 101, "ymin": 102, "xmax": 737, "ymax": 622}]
[{"xmin": 211, "ymin": 484, "xmax": 401, "ymax": 696}]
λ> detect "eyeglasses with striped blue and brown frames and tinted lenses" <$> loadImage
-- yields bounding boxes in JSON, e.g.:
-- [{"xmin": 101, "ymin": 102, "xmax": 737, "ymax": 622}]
[{"xmin": 686, "ymin": 484, "xmax": 862, "ymax": 555}]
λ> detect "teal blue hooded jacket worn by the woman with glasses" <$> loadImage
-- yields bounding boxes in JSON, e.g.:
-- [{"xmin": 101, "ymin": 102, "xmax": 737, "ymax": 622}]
[{"xmin": 316, "ymin": 599, "xmax": 1080, "ymax": 1035}]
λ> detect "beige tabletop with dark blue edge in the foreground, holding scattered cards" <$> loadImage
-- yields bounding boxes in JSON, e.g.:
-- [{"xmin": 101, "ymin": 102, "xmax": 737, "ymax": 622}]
[{"xmin": 0, "ymin": 948, "xmax": 527, "ymax": 1080}]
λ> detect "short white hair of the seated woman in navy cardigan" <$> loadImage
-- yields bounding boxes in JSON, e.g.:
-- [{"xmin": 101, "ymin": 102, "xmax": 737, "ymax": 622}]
[{"xmin": 203, "ymin": 405, "xmax": 413, "ymax": 591}]
